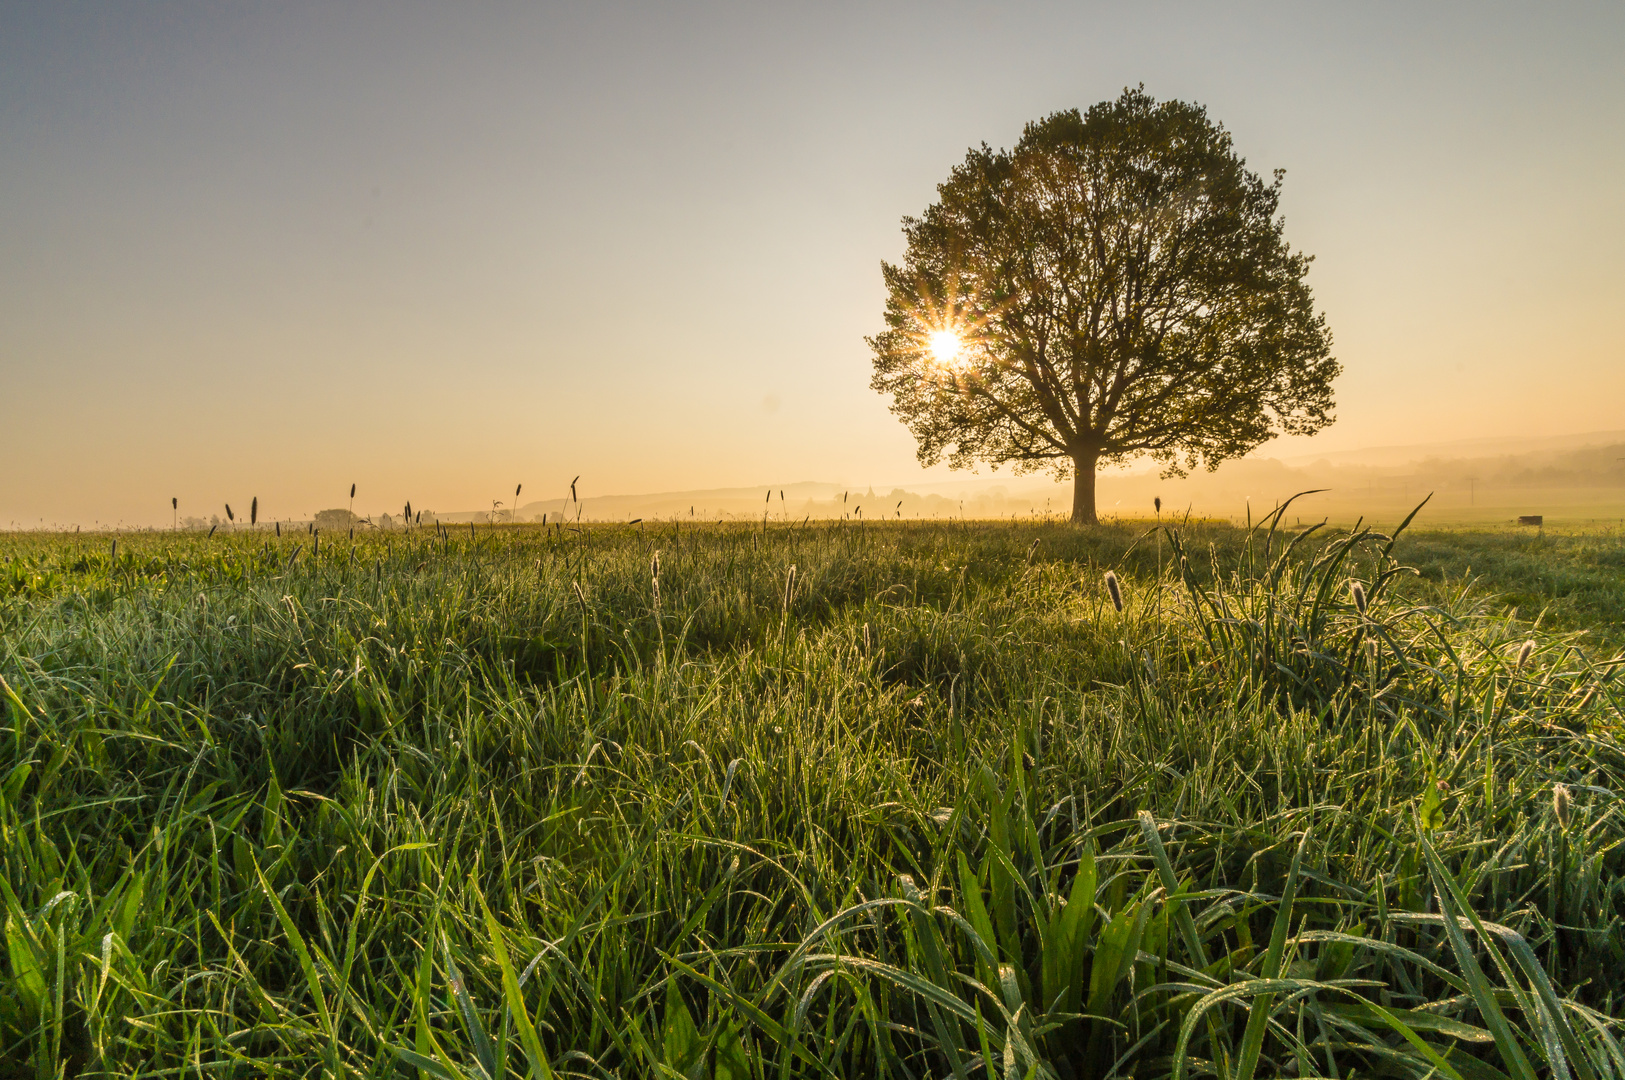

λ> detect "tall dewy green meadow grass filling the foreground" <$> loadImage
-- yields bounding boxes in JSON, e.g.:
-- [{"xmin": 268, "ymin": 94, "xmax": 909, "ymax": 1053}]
[{"xmin": 0, "ymin": 523, "xmax": 1625, "ymax": 1080}]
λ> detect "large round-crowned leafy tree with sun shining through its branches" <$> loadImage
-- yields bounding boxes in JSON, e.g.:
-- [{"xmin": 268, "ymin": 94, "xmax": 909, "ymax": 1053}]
[{"xmin": 868, "ymin": 89, "xmax": 1341, "ymax": 525}]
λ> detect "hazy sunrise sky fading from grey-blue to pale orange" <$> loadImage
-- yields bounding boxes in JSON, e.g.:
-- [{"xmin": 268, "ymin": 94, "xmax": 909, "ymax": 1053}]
[{"xmin": 0, "ymin": 0, "xmax": 1625, "ymax": 528}]
